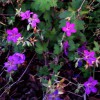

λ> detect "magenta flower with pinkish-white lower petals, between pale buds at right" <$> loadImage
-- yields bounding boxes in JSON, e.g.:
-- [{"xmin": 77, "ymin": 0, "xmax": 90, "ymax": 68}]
[{"xmin": 83, "ymin": 50, "xmax": 96, "ymax": 66}]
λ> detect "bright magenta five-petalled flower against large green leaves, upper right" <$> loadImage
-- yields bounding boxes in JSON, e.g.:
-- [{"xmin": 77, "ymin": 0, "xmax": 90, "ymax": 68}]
[{"xmin": 62, "ymin": 22, "xmax": 76, "ymax": 37}]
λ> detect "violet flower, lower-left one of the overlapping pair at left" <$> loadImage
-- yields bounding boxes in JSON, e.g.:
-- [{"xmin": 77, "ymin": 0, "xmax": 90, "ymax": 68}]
[{"xmin": 4, "ymin": 56, "xmax": 17, "ymax": 73}]
